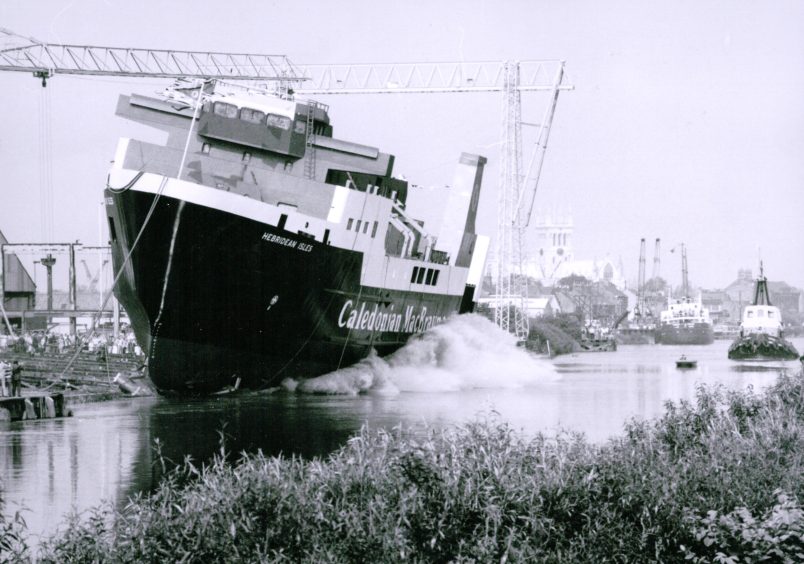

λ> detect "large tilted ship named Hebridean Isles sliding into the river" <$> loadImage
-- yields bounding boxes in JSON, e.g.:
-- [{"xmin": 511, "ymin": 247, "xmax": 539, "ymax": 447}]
[{"xmin": 105, "ymin": 82, "xmax": 488, "ymax": 394}]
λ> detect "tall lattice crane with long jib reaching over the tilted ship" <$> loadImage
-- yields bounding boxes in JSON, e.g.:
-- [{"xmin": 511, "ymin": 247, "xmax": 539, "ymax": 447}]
[{"xmin": 0, "ymin": 28, "xmax": 573, "ymax": 340}]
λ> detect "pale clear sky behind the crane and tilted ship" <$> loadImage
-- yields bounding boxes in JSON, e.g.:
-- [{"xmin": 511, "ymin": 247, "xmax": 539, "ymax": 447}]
[{"xmin": 0, "ymin": 0, "xmax": 804, "ymax": 288}]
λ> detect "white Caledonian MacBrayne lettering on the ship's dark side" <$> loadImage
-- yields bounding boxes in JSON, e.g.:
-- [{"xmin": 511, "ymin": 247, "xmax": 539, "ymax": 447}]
[{"xmin": 338, "ymin": 300, "xmax": 446, "ymax": 333}]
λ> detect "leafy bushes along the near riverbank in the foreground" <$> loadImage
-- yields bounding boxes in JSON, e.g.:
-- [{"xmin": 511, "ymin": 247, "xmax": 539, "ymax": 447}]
[{"xmin": 18, "ymin": 375, "xmax": 804, "ymax": 562}]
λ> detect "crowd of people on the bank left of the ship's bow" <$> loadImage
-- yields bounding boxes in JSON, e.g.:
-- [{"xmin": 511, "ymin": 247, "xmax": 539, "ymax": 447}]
[{"xmin": 0, "ymin": 329, "xmax": 142, "ymax": 357}]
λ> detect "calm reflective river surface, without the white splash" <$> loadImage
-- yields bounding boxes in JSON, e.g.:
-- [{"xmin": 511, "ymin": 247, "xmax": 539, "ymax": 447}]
[{"xmin": 0, "ymin": 339, "xmax": 804, "ymax": 548}]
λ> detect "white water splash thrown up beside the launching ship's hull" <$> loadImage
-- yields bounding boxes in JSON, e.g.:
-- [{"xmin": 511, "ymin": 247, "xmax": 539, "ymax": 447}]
[{"xmin": 283, "ymin": 314, "xmax": 559, "ymax": 394}]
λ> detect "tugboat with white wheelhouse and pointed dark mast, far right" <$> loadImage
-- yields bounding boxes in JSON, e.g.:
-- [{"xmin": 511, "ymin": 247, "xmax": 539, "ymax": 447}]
[{"xmin": 728, "ymin": 261, "xmax": 799, "ymax": 360}]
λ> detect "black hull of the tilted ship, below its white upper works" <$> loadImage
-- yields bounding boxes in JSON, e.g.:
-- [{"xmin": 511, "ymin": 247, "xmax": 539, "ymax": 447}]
[{"xmin": 106, "ymin": 190, "xmax": 464, "ymax": 394}]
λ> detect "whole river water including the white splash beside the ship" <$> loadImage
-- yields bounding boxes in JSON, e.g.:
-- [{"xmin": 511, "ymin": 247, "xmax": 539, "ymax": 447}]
[{"xmin": 0, "ymin": 316, "xmax": 804, "ymax": 543}]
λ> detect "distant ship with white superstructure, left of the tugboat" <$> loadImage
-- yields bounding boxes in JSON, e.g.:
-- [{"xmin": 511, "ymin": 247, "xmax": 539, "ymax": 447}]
[{"xmin": 654, "ymin": 243, "xmax": 715, "ymax": 345}]
